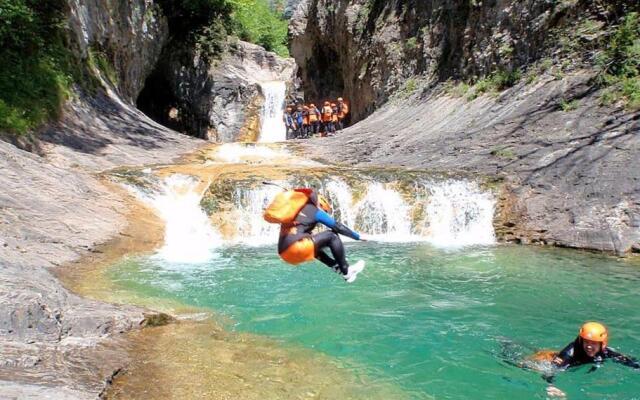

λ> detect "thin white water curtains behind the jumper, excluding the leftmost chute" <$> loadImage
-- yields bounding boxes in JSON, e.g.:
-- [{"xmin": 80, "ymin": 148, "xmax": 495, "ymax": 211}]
[{"xmin": 218, "ymin": 178, "xmax": 495, "ymax": 247}]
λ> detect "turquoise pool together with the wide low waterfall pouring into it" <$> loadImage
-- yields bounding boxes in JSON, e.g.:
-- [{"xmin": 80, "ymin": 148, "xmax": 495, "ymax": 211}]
[{"xmin": 109, "ymin": 145, "xmax": 640, "ymax": 399}]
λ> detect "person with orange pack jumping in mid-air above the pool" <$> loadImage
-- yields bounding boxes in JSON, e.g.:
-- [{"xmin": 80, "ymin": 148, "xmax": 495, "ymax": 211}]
[{"xmin": 264, "ymin": 188, "xmax": 364, "ymax": 283}]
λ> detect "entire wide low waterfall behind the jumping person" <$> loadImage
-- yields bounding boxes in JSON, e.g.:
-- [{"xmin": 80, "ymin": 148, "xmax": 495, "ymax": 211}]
[{"xmin": 125, "ymin": 170, "xmax": 495, "ymax": 252}]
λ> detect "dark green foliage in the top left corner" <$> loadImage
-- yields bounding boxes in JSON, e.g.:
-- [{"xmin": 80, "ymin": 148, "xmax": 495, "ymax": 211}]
[{"xmin": 0, "ymin": 0, "xmax": 75, "ymax": 135}]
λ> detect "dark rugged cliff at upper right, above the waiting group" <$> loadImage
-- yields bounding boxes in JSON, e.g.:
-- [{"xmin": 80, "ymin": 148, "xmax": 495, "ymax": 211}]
[{"xmin": 290, "ymin": 0, "xmax": 624, "ymax": 121}]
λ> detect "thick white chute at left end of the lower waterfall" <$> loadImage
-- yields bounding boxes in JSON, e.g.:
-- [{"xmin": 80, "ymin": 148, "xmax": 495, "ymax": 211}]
[{"xmin": 137, "ymin": 174, "xmax": 222, "ymax": 264}]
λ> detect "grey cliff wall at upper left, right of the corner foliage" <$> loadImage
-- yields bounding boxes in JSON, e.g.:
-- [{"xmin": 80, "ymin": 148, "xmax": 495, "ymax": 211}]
[{"xmin": 68, "ymin": 0, "xmax": 169, "ymax": 104}]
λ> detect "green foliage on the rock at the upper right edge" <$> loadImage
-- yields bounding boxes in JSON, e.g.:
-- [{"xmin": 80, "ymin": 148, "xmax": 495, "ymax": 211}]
[{"xmin": 597, "ymin": 12, "xmax": 640, "ymax": 109}]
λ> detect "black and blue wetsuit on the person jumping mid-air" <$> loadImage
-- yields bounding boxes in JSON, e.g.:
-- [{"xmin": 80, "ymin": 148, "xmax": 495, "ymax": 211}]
[{"xmin": 278, "ymin": 192, "xmax": 360, "ymax": 275}]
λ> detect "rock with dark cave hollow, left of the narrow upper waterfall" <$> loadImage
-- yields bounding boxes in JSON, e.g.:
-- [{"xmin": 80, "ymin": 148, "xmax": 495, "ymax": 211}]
[{"xmin": 138, "ymin": 41, "xmax": 296, "ymax": 142}]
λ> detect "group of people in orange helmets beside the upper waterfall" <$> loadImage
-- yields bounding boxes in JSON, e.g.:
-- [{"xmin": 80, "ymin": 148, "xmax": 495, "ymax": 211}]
[{"xmin": 282, "ymin": 97, "xmax": 349, "ymax": 140}]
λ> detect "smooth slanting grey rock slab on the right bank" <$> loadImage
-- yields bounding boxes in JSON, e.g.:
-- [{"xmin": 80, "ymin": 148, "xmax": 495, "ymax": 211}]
[{"xmin": 307, "ymin": 74, "xmax": 640, "ymax": 254}]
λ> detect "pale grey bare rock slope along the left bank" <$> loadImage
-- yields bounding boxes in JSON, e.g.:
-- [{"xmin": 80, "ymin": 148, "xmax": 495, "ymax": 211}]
[{"xmin": 0, "ymin": 88, "xmax": 203, "ymax": 399}]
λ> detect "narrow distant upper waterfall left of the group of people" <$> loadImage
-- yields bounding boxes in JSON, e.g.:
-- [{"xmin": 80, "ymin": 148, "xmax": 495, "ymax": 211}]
[{"xmin": 259, "ymin": 81, "xmax": 287, "ymax": 143}]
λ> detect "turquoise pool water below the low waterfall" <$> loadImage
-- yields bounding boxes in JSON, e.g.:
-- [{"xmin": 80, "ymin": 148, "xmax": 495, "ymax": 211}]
[{"xmin": 112, "ymin": 243, "xmax": 640, "ymax": 399}]
